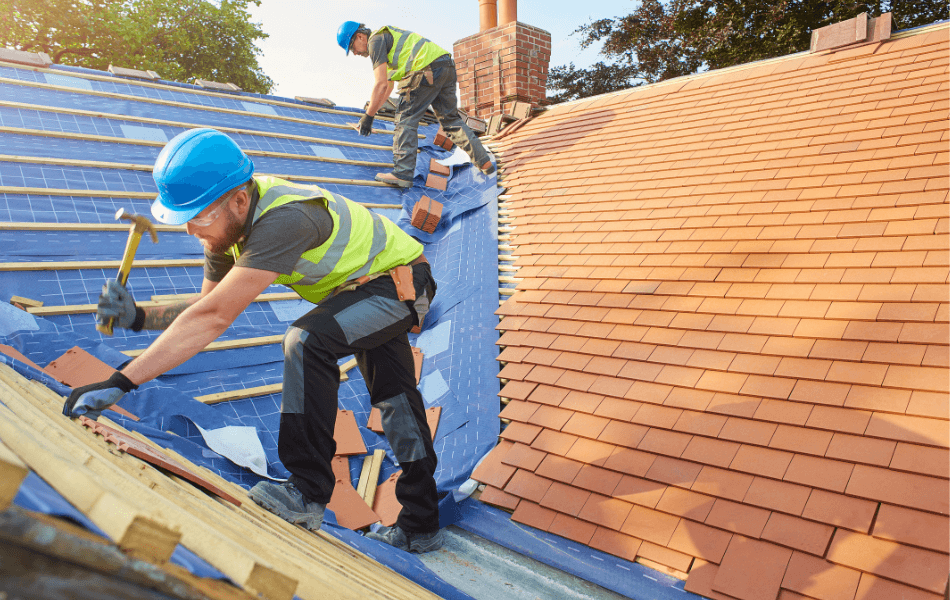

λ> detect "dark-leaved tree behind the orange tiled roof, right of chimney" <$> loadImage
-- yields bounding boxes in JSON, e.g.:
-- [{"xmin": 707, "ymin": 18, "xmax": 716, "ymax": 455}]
[{"xmin": 548, "ymin": 0, "xmax": 950, "ymax": 102}]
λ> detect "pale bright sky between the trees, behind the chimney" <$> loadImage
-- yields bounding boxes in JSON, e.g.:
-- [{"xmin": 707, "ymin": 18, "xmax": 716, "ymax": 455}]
[{"xmin": 250, "ymin": 0, "xmax": 636, "ymax": 108}]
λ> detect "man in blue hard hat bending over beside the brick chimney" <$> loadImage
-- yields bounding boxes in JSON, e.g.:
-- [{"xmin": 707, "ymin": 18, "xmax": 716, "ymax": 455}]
[{"xmin": 336, "ymin": 21, "xmax": 495, "ymax": 188}]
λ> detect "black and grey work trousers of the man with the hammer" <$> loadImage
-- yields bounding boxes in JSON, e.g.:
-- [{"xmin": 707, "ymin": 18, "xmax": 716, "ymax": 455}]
[{"xmin": 277, "ymin": 263, "xmax": 439, "ymax": 533}]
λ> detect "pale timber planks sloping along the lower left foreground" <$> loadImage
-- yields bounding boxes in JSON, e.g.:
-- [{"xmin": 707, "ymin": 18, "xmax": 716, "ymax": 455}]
[{"xmin": 0, "ymin": 365, "xmax": 436, "ymax": 600}]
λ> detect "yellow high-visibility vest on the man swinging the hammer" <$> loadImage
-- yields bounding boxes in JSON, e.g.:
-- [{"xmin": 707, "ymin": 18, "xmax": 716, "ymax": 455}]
[{"xmin": 230, "ymin": 176, "xmax": 422, "ymax": 304}]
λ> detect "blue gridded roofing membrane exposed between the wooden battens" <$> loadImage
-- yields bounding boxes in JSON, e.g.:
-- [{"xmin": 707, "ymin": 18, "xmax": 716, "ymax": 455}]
[{"xmin": 0, "ymin": 61, "xmax": 499, "ymax": 598}]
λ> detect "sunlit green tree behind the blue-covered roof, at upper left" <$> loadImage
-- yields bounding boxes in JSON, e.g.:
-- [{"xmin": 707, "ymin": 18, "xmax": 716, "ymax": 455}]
[{"xmin": 0, "ymin": 0, "xmax": 274, "ymax": 93}]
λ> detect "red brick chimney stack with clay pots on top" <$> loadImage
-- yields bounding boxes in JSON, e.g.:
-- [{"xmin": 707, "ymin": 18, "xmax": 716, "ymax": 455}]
[{"xmin": 453, "ymin": 0, "xmax": 551, "ymax": 120}]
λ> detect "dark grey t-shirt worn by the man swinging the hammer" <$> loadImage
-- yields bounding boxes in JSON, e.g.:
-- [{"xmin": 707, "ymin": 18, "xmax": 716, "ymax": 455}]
[{"xmin": 204, "ymin": 196, "xmax": 333, "ymax": 281}]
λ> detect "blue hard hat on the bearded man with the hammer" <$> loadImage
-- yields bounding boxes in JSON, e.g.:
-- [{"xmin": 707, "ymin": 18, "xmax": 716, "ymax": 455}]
[{"xmin": 152, "ymin": 128, "xmax": 254, "ymax": 225}]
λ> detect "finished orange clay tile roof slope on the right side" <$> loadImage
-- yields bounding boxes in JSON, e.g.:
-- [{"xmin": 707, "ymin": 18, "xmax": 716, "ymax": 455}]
[{"xmin": 475, "ymin": 25, "xmax": 950, "ymax": 600}]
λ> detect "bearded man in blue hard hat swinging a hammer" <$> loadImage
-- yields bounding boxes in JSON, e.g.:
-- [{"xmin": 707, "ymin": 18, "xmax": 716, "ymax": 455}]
[{"xmin": 63, "ymin": 129, "xmax": 443, "ymax": 552}]
